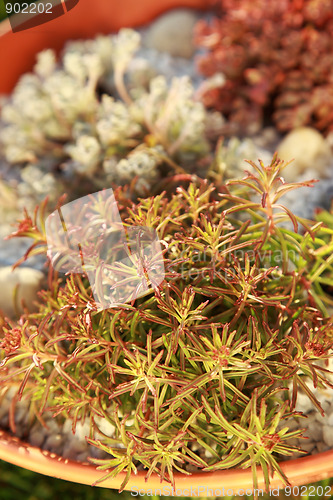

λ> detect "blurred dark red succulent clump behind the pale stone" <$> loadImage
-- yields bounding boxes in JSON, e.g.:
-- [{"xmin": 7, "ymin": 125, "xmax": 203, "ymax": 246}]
[{"xmin": 195, "ymin": 0, "xmax": 333, "ymax": 133}]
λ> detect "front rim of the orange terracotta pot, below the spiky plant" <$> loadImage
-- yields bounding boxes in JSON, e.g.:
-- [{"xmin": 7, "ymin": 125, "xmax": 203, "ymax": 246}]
[{"xmin": 0, "ymin": 430, "xmax": 333, "ymax": 496}]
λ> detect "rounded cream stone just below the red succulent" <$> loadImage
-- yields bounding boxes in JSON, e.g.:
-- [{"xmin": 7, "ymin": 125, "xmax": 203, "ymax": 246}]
[{"xmin": 277, "ymin": 127, "xmax": 332, "ymax": 182}]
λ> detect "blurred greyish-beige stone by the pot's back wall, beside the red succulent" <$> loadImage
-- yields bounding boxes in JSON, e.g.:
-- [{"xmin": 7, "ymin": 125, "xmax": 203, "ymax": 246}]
[{"xmin": 144, "ymin": 9, "xmax": 198, "ymax": 59}]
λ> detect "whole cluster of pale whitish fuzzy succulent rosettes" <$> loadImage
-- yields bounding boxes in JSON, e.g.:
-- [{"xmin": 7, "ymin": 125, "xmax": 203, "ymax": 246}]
[{"xmin": 0, "ymin": 28, "xmax": 211, "ymax": 203}]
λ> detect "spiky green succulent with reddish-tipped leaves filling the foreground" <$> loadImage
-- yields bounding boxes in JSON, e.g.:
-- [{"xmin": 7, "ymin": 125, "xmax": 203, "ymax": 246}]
[{"xmin": 0, "ymin": 158, "xmax": 333, "ymax": 489}]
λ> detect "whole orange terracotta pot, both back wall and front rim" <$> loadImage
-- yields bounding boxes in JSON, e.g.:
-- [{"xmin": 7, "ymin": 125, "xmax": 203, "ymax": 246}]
[{"xmin": 0, "ymin": 0, "xmax": 333, "ymax": 496}]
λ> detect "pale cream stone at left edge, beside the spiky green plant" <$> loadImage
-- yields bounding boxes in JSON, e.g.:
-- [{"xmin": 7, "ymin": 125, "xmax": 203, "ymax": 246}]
[{"xmin": 0, "ymin": 266, "xmax": 44, "ymax": 317}]
